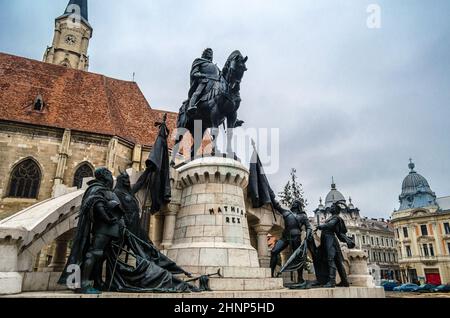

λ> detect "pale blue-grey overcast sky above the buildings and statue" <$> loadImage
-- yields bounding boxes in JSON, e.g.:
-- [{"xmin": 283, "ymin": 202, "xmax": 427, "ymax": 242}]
[{"xmin": 0, "ymin": 0, "xmax": 450, "ymax": 218}]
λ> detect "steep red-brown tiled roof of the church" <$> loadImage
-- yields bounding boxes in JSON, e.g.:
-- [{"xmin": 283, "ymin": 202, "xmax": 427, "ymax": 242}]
[{"xmin": 0, "ymin": 53, "xmax": 177, "ymax": 146}]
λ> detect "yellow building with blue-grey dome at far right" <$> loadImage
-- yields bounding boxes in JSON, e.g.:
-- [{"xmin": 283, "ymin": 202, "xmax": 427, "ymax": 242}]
[{"xmin": 392, "ymin": 160, "xmax": 450, "ymax": 285}]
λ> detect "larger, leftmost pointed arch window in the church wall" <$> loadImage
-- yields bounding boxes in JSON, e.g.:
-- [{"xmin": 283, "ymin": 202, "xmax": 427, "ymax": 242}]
[{"xmin": 8, "ymin": 159, "xmax": 41, "ymax": 199}]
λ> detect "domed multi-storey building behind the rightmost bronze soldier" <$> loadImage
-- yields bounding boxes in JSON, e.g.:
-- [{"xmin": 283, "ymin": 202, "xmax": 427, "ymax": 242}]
[{"xmin": 311, "ymin": 178, "xmax": 400, "ymax": 283}]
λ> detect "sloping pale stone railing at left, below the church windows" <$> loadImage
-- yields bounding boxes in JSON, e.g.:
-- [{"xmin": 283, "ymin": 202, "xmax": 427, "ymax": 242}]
[{"xmin": 0, "ymin": 190, "xmax": 84, "ymax": 294}]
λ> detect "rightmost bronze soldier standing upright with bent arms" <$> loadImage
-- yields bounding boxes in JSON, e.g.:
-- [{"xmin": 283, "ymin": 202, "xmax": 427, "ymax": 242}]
[{"xmin": 316, "ymin": 202, "xmax": 355, "ymax": 288}]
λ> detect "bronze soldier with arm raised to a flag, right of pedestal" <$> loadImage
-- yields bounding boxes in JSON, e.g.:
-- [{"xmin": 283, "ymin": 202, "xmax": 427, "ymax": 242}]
[{"xmin": 270, "ymin": 197, "xmax": 312, "ymax": 284}]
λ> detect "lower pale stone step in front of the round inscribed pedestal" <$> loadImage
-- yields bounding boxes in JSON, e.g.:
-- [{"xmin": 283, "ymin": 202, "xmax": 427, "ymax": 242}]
[{"xmin": 209, "ymin": 278, "xmax": 283, "ymax": 291}]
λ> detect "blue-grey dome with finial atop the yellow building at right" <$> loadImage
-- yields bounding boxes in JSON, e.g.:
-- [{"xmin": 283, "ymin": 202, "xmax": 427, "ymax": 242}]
[{"xmin": 400, "ymin": 159, "xmax": 436, "ymax": 210}]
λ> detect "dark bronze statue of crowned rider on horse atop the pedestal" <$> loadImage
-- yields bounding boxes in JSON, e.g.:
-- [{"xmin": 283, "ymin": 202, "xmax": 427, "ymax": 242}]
[{"xmin": 171, "ymin": 48, "xmax": 248, "ymax": 166}]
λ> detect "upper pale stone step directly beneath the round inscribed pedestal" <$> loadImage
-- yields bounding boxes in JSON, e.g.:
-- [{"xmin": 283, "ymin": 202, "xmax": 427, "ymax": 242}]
[{"xmin": 184, "ymin": 266, "xmax": 271, "ymax": 278}]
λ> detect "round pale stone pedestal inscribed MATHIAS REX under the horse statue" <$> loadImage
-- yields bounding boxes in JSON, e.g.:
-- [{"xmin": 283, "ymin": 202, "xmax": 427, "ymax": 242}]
[{"xmin": 166, "ymin": 157, "xmax": 282, "ymax": 290}]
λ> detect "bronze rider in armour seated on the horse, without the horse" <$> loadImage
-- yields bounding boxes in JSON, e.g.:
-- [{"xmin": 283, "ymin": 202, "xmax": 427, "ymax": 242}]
[{"xmin": 187, "ymin": 48, "xmax": 220, "ymax": 116}]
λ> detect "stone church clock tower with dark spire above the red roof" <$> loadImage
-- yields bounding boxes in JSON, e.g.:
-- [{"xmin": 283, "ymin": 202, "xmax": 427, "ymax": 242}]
[{"xmin": 44, "ymin": 0, "xmax": 93, "ymax": 71}]
